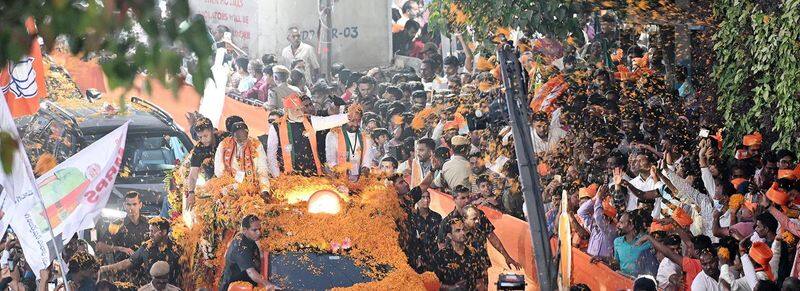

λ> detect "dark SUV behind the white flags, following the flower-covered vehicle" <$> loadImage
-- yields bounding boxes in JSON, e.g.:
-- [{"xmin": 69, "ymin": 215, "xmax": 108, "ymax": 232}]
[{"xmin": 17, "ymin": 91, "xmax": 192, "ymax": 218}]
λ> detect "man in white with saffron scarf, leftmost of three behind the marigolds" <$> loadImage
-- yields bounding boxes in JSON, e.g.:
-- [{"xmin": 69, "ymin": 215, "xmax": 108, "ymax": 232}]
[{"xmin": 214, "ymin": 121, "xmax": 269, "ymax": 194}]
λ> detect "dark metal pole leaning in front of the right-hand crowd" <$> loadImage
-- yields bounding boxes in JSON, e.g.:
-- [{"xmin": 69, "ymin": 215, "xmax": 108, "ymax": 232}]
[{"xmin": 497, "ymin": 42, "xmax": 558, "ymax": 290}]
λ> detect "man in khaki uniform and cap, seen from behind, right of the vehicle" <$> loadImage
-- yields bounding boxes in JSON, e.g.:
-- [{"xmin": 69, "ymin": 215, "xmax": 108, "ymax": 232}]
[{"xmin": 433, "ymin": 135, "xmax": 472, "ymax": 189}]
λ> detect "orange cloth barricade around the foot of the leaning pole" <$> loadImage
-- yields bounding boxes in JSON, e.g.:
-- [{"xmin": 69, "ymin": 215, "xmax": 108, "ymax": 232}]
[{"xmin": 430, "ymin": 190, "xmax": 633, "ymax": 291}]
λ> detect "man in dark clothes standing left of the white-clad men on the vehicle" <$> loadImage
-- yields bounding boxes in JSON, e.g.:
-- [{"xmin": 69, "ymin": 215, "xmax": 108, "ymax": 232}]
[{"xmin": 185, "ymin": 117, "xmax": 223, "ymax": 207}]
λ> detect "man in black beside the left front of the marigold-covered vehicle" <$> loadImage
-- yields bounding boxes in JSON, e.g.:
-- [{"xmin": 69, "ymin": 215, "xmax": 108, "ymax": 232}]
[{"xmin": 219, "ymin": 214, "xmax": 275, "ymax": 291}]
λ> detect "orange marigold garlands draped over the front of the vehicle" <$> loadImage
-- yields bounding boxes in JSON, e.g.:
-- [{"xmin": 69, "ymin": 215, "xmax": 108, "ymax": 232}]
[{"xmin": 172, "ymin": 171, "xmax": 430, "ymax": 290}]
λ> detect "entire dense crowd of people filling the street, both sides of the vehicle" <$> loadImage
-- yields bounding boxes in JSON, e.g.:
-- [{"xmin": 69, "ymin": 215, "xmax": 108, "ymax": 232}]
[{"xmin": 3, "ymin": 1, "xmax": 800, "ymax": 290}]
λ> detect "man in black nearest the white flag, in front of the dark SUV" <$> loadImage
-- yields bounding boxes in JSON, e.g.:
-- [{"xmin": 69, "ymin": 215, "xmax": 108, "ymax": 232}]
[{"xmin": 97, "ymin": 191, "xmax": 148, "ymax": 281}]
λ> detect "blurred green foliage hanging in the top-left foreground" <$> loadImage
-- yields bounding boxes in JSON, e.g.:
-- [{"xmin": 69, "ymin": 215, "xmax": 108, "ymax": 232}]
[{"xmin": 0, "ymin": 0, "xmax": 212, "ymax": 92}]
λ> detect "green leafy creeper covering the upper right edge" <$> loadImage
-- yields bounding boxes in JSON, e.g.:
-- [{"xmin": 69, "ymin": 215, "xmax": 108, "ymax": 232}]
[{"xmin": 714, "ymin": 0, "xmax": 800, "ymax": 151}]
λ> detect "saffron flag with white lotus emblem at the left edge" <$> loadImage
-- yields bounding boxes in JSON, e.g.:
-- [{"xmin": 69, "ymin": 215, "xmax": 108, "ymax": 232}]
[{"xmin": 0, "ymin": 19, "xmax": 47, "ymax": 118}]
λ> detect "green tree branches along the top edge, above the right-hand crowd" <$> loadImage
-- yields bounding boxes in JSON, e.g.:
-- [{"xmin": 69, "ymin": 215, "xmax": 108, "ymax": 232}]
[{"xmin": 429, "ymin": 0, "xmax": 696, "ymax": 54}]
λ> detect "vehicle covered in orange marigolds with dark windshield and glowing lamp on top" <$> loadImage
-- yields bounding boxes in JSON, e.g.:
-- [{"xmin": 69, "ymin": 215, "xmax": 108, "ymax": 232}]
[{"xmin": 164, "ymin": 166, "xmax": 437, "ymax": 290}]
